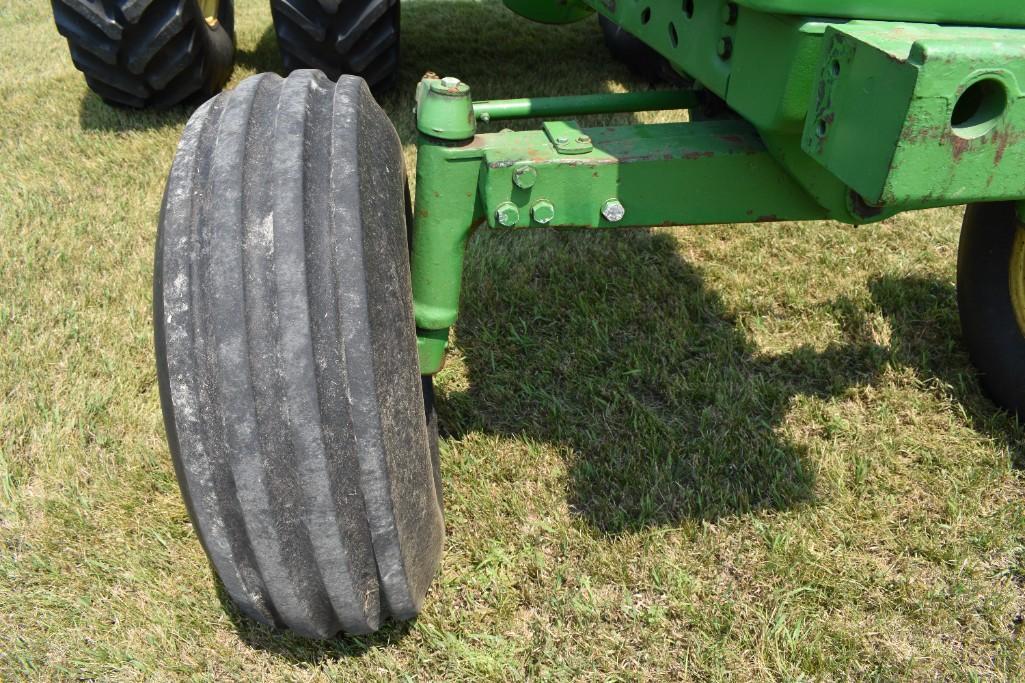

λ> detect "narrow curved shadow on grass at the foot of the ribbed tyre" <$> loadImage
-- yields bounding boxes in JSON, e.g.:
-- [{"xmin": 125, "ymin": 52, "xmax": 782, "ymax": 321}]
[{"xmin": 211, "ymin": 569, "xmax": 413, "ymax": 665}]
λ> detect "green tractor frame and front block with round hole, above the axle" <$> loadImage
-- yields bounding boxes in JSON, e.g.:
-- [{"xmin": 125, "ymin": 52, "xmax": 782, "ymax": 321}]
[{"xmin": 587, "ymin": 0, "xmax": 1025, "ymax": 214}]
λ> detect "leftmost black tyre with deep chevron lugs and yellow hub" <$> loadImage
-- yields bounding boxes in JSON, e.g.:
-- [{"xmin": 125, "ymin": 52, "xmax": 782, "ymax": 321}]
[{"xmin": 52, "ymin": 0, "xmax": 235, "ymax": 108}]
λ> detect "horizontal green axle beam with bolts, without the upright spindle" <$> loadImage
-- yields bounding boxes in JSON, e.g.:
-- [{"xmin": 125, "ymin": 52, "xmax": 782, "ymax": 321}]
[{"xmin": 475, "ymin": 120, "xmax": 827, "ymax": 229}]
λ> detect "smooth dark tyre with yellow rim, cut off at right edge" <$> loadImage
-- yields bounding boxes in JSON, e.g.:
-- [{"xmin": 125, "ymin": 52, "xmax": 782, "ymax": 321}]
[{"xmin": 957, "ymin": 203, "xmax": 1025, "ymax": 416}]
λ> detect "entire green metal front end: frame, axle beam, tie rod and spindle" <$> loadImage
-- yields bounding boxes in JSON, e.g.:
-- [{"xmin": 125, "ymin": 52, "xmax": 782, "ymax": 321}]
[{"xmin": 411, "ymin": 0, "xmax": 1025, "ymax": 373}]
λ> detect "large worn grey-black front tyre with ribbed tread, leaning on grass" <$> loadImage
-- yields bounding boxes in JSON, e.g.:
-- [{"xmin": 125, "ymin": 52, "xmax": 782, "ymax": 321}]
[{"xmin": 154, "ymin": 71, "xmax": 445, "ymax": 638}]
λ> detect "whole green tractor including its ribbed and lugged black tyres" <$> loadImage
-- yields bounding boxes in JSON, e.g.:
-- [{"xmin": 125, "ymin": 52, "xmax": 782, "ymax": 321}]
[{"xmin": 54, "ymin": 0, "xmax": 1025, "ymax": 637}]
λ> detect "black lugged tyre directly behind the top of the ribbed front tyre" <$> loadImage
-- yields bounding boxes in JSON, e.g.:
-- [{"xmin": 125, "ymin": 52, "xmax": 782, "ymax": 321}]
[{"xmin": 271, "ymin": 0, "xmax": 399, "ymax": 89}]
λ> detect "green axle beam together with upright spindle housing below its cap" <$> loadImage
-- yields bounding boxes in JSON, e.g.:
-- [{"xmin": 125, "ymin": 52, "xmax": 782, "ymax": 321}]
[{"xmin": 411, "ymin": 120, "xmax": 828, "ymax": 374}]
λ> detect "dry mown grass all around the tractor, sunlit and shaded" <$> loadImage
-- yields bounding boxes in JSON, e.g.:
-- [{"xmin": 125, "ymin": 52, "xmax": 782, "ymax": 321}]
[{"xmin": 0, "ymin": 0, "xmax": 1025, "ymax": 681}]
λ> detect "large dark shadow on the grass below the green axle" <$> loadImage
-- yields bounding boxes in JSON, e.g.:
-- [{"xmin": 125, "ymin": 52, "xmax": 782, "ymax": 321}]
[{"xmin": 439, "ymin": 232, "xmax": 1021, "ymax": 534}]
